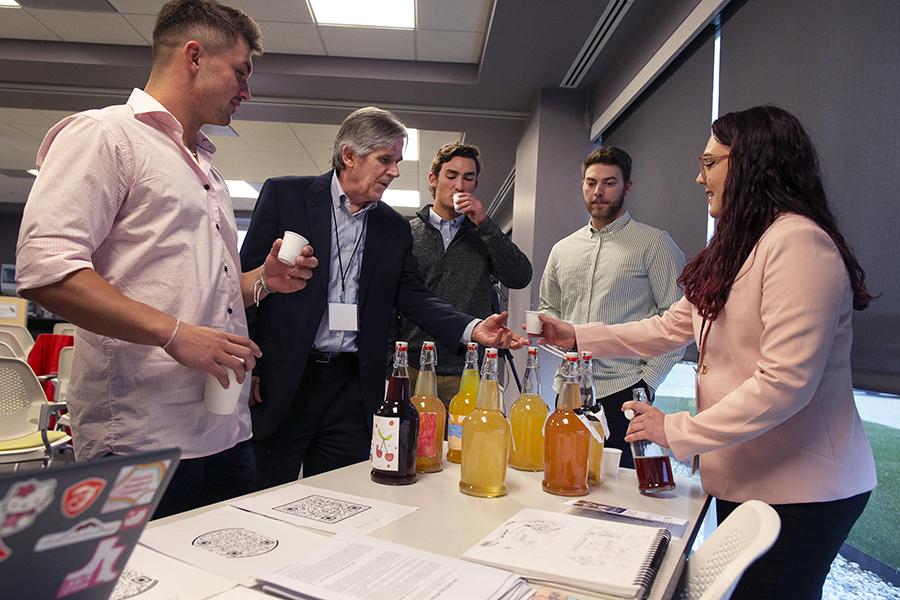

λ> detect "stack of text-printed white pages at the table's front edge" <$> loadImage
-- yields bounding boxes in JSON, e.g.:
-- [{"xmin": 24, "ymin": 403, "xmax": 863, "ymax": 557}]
[{"xmin": 258, "ymin": 534, "xmax": 533, "ymax": 600}]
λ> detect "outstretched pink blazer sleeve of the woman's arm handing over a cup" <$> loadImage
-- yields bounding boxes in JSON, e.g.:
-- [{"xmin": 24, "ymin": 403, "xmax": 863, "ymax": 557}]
[{"xmin": 575, "ymin": 298, "xmax": 694, "ymax": 358}]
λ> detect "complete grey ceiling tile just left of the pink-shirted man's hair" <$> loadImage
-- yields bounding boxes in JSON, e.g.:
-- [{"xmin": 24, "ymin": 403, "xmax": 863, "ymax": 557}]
[{"xmin": 28, "ymin": 9, "xmax": 147, "ymax": 46}]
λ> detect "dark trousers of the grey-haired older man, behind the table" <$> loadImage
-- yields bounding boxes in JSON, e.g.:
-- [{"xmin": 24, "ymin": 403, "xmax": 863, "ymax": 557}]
[{"xmin": 253, "ymin": 353, "xmax": 372, "ymax": 489}]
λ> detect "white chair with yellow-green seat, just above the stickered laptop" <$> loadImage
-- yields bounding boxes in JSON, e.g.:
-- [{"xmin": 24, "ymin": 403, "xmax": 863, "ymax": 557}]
[{"xmin": 0, "ymin": 358, "xmax": 71, "ymax": 470}]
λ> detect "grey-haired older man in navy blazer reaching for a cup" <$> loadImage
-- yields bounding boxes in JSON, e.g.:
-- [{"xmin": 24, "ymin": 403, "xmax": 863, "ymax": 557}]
[{"xmin": 241, "ymin": 107, "xmax": 524, "ymax": 487}]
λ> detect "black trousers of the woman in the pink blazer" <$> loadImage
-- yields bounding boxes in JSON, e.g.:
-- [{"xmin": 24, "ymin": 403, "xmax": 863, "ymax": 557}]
[{"xmin": 716, "ymin": 492, "xmax": 870, "ymax": 600}]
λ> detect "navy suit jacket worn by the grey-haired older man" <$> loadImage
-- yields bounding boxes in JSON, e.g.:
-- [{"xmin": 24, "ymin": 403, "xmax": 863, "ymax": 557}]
[{"xmin": 241, "ymin": 171, "xmax": 474, "ymax": 440}]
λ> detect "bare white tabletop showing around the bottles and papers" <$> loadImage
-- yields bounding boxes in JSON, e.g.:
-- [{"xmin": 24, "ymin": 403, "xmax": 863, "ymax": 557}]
[{"xmin": 149, "ymin": 462, "xmax": 709, "ymax": 599}]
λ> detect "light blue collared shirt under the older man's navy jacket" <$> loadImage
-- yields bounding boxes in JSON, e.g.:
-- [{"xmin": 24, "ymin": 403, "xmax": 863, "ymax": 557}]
[{"xmin": 315, "ymin": 172, "xmax": 378, "ymax": 352}]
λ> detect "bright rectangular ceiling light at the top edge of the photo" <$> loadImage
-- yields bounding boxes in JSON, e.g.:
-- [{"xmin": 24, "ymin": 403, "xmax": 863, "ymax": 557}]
[{"xmin": 309, "ymin": 0, "xmax": 416, "ymax": 29}]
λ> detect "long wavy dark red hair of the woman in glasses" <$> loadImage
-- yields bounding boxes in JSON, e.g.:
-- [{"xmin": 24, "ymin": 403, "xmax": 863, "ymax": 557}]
[{"xmin": 678, "ymin": 106, "xmax": 872, "ymax": 321}]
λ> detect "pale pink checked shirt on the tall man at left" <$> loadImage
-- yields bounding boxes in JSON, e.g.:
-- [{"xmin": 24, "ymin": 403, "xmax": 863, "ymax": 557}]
[{"xmin": 16, "ymin": 89, "xmax": 251, "ymax": 460}]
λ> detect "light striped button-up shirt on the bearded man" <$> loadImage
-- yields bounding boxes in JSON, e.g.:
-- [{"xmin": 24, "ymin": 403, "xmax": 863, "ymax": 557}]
[{"xmin": 539, "ymin": 211, "xmax": 684, "ymax": 397}]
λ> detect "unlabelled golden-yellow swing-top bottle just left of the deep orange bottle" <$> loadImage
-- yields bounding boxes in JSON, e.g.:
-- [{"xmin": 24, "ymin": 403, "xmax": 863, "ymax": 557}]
[{"xmin": 509, "ymin": 346, "xmax": 547, "ymax": 471}]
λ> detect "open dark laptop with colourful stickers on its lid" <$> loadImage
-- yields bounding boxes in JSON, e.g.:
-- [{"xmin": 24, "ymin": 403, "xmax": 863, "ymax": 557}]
[{"xmin": 0, "ymin": 449, "xmax": 181, "ymax": 600}]
